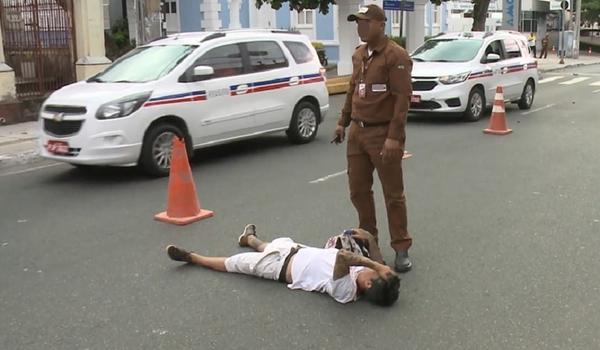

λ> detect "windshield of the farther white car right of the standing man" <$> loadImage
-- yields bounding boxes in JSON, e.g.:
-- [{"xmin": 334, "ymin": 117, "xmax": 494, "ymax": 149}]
[{"xmin": 411, "ymin": 39, "xmax": 483, "ymax": 62}]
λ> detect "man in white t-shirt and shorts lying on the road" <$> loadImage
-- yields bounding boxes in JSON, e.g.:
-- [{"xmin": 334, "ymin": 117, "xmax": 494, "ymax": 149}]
[{"xmin": 167, "ymin": 225, "xmax": 400, "ymax": 306}]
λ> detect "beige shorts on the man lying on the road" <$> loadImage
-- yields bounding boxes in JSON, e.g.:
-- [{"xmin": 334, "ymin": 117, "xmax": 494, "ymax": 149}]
[{"xmin": 225, "ymin": 237, "xmax": 298, "ymax": 280}]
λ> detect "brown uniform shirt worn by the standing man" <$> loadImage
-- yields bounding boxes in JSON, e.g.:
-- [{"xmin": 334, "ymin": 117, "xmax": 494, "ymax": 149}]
[{"xmin": 338, "ymin": 38, "xmax": 412, "ymax": 143}]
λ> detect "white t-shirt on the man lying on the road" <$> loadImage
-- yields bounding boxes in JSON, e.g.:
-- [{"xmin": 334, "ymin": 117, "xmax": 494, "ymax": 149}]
[{"xmin": 288, "ymin": 247, "xmax": 364, "ymax": 303}]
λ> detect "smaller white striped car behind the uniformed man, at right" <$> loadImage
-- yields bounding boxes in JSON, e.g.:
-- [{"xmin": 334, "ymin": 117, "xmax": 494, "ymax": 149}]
[{"xmin": 410, "ymin": 31, "xmax": 539, "ymax": 121}]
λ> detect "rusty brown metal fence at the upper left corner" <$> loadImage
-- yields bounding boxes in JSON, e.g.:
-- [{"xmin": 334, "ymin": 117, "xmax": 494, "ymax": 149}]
[{"xmin": 0, "ymin": 0, "xmax": 75, "ymax": 100}]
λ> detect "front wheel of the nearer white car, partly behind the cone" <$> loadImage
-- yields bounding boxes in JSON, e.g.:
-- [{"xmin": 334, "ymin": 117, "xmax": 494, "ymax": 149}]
[{"xmin": 139, "ymin": 123, "xmax": 190, "ymax": 177}]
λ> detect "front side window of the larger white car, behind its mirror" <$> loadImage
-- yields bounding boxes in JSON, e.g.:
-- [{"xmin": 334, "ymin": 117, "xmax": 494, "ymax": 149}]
[{"xmin": 194, "ymin": 44, "xmax": 244, "ymax": 78}]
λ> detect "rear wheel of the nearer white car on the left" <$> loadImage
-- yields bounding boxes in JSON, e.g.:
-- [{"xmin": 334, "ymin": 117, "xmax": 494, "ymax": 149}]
[{"xmin": 286, "ymin": 101, "xmax": 319, "ymax": 144}]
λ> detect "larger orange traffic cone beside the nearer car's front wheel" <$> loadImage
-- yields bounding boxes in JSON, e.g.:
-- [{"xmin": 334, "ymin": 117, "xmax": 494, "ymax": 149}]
[{"xmin": 154, "ymin": 137, "xmax": 214, "ymax": 225}]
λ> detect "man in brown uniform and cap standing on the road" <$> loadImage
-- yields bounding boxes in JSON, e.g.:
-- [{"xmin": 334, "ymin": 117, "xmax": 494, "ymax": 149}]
[{"xmin": 334, "ymin": 5, "xmax": 412, "ymax": 272}]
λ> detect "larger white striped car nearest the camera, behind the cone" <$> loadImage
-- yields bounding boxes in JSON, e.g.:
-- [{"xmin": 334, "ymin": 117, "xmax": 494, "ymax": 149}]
[{"xmin": 40, "ymin": 30, "xmax": 329, "ymax": 176}]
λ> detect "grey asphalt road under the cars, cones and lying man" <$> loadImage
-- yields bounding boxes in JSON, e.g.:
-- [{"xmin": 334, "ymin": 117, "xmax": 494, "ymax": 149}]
[{"xmin": 0, "ymin": 66, "xmax": 600, "ymax": 350}]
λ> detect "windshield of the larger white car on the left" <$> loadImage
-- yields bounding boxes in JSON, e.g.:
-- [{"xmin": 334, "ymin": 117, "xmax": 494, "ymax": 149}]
[{"xmin": 88, "ymin": 45, "xmax": 198, "ymax": 83}]
